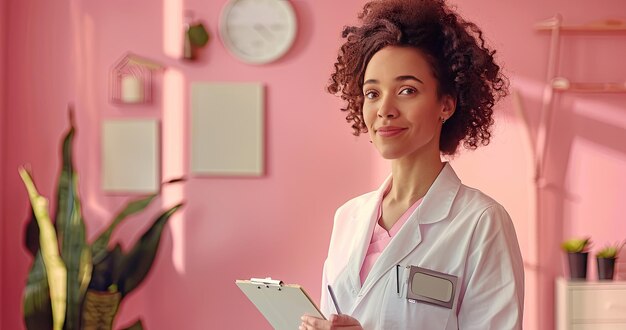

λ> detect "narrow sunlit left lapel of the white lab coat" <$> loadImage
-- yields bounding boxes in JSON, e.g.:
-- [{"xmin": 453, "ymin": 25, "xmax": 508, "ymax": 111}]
[{"xmin": 348, "ymin": 176, "xmax": 391, "ymax": 291}]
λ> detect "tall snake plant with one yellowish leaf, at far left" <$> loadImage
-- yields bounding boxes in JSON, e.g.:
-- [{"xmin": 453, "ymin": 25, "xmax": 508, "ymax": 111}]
[{"xmin": 19, "ymin": 109, "xmax": 182, "ymax": 330}]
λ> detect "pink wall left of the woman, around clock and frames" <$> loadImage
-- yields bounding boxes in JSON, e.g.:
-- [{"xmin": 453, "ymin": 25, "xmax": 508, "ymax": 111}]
[{"xmin": 1, "ymin": 1, "xmax": 372, "ymax": 329}]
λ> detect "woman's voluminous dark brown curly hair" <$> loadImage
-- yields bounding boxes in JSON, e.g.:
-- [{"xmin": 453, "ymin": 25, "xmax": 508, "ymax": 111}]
[{"xmin": 327, "ymin": 0, "xmax": 508, "ymax": 155}]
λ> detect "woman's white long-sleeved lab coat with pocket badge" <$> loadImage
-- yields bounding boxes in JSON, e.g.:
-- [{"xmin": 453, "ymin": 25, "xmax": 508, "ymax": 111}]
[{"xmin": 320, "ymin": 164, "xmax": 524, "ymax": 330}]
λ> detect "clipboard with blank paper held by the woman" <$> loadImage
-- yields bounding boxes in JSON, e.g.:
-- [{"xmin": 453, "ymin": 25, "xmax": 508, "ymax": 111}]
[{"xmin": 235, "ymin": 277, "xmax": 326, "ymax": 330}]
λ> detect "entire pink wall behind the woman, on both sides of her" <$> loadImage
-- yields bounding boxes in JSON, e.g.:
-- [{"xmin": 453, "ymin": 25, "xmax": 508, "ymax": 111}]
[{"xmin": 0, "ymin": 0, "xmax": 626, "ymax": 330}]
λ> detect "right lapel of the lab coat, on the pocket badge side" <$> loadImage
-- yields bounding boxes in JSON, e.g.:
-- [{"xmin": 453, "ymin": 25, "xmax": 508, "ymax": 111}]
[{"xmin": 355, "ymin": 163, "xmax": 461, "ymax": 308}]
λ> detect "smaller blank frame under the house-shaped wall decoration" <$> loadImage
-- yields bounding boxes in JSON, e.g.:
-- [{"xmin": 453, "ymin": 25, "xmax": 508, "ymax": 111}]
[{"xmin": 101, "ymin": 119, "xmax": 160, "ymax": 193}]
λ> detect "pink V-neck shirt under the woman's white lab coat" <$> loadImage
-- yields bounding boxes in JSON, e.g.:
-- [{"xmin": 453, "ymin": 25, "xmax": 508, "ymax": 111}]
[{"xmin": 360, "ymin": 198, "xmax": 424, "ymax": 285}]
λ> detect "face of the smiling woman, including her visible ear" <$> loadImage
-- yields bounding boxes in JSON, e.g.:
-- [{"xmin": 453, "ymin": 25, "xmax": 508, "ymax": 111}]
[{"xmin": 363, "ymin": 46, "xmax": 454, "ymax": 159}]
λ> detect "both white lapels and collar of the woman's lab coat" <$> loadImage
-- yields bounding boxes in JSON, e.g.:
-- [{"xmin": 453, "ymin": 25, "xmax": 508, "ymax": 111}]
[{"xmin": 348, "ymin": 163, "xmax": 461, "ymax": 312}]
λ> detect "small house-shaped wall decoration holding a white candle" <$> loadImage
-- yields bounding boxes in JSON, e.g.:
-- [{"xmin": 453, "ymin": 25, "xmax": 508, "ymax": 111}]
[{"xmin": 109, "ymin": 53, "xmax": 163, "ymax": 104}]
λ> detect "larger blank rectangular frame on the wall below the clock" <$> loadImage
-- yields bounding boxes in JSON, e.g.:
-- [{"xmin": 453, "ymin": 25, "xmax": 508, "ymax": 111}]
[{"xmin": 190, "ymin": 82, "xmax": 265, "ymax": 176}]
